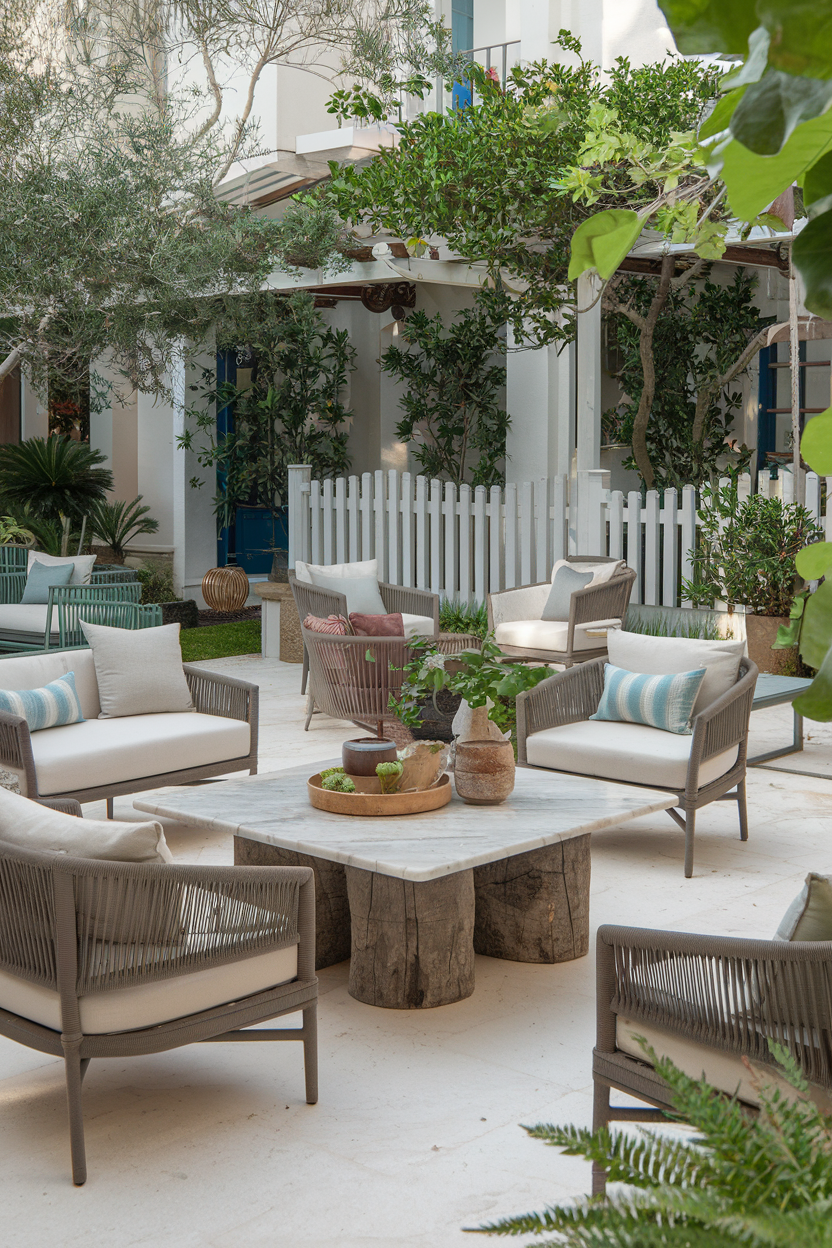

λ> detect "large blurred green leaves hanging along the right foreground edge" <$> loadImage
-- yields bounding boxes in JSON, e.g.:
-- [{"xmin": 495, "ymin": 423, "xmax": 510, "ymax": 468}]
[{"xmin": 638, "ymin": 9, "xmax": 832, "ymax": 721}]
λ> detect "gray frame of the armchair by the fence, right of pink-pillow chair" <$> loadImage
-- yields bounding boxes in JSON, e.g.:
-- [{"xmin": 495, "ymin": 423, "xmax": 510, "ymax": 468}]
[{"xmin": 488, "ymin": 554, "xmax": 636, "ymax": 668}]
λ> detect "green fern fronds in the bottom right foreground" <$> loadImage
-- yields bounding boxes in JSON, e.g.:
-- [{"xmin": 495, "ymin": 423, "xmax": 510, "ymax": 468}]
[{"xmin": 472, "ymin": 1041, "xmax": 832, "ymax": 1248}]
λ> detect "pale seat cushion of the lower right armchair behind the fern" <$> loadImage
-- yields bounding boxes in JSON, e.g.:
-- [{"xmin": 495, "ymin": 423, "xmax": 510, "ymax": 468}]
[{"xmin": 615, "ymin": 1016, "xmax": 832, "ymax": 1113}]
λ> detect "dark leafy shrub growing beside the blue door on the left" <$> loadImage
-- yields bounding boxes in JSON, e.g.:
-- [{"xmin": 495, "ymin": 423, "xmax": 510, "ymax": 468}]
[{"xmin": 178, "ymin": 292, "xmax": 356, "ymax": 528}]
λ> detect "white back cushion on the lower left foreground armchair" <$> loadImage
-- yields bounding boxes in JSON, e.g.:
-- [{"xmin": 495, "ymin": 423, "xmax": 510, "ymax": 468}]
[{"xmin": 0, "ymin": 787, "xmax": 173, "ymax": 862}]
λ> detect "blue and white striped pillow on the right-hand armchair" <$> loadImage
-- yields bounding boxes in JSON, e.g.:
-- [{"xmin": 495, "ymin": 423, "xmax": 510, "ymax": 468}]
[{"xmin": 590, "ymin": 663, "xmax": 705, "ymax": 736}]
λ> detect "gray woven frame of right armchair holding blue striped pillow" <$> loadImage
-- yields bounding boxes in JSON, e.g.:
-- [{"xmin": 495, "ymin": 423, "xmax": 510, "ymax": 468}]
[{"xmin": 516, "ymin": 659, "xmax": 757, "ymax": 879}]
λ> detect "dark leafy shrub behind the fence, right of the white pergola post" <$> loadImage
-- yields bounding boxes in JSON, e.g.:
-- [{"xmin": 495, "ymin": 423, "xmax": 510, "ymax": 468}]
[{"xmin": 605, "ymin": 266, "xmax": 761, "ymax": 489}]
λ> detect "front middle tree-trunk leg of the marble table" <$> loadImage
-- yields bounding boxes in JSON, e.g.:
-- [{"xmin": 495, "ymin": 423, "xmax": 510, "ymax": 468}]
[{"xmin": 347, "ymin": 866, "xmax": 474, "ymax": 1010}]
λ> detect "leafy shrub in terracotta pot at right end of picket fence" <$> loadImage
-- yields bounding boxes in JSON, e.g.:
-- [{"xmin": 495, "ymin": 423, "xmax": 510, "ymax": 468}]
[{"xmin": 684, "ymin": 482, "xmax": 823, "ymax": 675}]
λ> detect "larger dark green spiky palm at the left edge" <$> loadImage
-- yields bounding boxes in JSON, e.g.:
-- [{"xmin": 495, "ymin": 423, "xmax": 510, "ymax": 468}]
[{"xmin": 0, "ymin": 436, "xmax": 112, "ymax": 555}]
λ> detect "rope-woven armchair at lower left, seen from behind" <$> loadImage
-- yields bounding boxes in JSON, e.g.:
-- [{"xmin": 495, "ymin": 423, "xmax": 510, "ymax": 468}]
[{"xmin": 0, "ymin": 823, "xmax": 318, "ymax": 1184}]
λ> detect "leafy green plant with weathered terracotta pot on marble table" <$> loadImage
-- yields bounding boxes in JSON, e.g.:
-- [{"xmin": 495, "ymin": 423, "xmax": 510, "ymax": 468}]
[{"xmin": 390, "ymin": 639, "xmax": 551, "ymax": 805}]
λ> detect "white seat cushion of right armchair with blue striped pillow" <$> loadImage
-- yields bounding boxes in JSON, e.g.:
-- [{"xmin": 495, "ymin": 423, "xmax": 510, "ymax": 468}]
[{"xmin": 523, "ymin": 720, "xmax": 738, "ymax": 792}]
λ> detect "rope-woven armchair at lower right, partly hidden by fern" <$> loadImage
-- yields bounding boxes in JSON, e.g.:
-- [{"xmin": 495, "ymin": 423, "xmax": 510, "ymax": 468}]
[{"xmin": 593, "ymin": 926, "xmax": 832, "ymax": 1194}]
